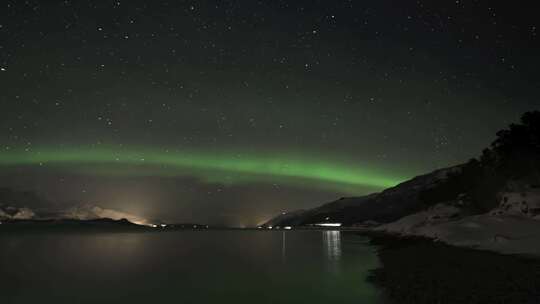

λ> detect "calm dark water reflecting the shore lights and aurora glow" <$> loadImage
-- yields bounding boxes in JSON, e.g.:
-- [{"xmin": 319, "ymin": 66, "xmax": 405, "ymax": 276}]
[{"xmin": 0, "ymin": 231, "xmax": 379, "ymax": 304}]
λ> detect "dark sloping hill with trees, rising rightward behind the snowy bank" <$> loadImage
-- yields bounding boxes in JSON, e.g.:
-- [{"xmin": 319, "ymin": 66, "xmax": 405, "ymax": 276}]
[{"xmin": 265, "ymin": 111, "xmax": 540, "ymax": 226}]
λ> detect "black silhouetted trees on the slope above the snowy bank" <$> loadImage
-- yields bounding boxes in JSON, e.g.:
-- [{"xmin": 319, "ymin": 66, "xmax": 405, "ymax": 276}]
[{"xmin": 420, "ymin": 111, "xmax": 540, "ymax": 213}]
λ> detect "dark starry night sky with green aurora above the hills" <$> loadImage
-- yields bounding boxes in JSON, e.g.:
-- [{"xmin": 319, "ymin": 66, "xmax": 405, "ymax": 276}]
[{"xmin": 0, "ymin": 0, "xmax": 540, "ymax": 225}]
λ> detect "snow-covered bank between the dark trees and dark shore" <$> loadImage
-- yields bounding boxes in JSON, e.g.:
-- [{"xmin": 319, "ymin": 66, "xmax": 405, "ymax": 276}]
[{"xmin": 374, "ymin": 183, "xmax": 540, "ymax": 256}]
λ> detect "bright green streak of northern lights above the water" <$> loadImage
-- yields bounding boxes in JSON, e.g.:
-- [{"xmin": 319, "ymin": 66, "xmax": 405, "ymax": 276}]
[{"xmin": 0, "ymin": 148, "xmax": 403, "ymax": 194}]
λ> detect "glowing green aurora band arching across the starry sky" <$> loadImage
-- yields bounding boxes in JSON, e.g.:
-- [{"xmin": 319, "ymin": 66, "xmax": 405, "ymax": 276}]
[{"xmin": 0, "ymin": 148, "xmax": 405, "ymax": 194}]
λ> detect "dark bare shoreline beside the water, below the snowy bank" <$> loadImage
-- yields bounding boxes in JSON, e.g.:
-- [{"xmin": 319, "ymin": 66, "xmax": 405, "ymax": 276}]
[{"xmin": 369, "ymin": 236, "xmax": 540, "ymax": 304}]
